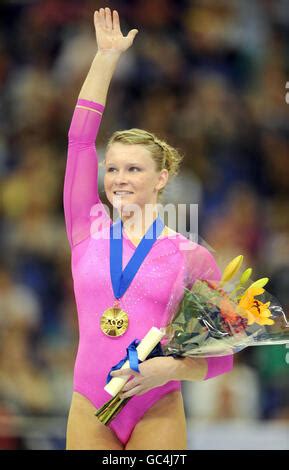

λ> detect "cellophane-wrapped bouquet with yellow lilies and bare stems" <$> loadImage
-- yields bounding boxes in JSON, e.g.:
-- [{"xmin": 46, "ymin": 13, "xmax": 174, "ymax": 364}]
[{"xmin": 96, "ymin": 255, "xmax": 289, "ymax": 424}]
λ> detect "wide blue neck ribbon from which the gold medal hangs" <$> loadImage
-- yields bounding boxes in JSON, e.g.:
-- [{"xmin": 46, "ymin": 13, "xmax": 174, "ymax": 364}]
[{"xmin": 110, "ymin": 216, "xmax": 164, "ymax": 299}]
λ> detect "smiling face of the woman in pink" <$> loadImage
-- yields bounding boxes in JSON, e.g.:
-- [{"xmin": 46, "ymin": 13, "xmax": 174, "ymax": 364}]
[{"xmin": 104, "ymin": 142, "xmax": 168, "ymax": 214}]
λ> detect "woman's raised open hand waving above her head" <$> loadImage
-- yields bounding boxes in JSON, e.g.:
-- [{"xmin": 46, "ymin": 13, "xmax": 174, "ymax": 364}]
[{"xmin": 94, "ymin": 8, "xmax": 138, "ymax": 54}]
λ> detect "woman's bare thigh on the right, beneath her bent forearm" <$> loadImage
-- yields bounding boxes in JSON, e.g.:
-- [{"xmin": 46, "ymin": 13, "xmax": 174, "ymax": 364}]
[{"xmin": 125, "ymin": 391, "xmax": 187, "ymax": 450}]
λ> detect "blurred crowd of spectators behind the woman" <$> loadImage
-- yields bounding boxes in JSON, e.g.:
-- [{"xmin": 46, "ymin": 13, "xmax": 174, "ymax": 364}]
[{"xmin": 0, "ymin": 0, "xmax": 289, "ymax": 449}]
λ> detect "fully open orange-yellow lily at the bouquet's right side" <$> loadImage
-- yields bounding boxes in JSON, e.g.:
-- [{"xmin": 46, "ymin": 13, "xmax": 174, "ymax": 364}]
[{"xmin": 238, "ymin": 287, "xmax": 274, "ymax": 325}]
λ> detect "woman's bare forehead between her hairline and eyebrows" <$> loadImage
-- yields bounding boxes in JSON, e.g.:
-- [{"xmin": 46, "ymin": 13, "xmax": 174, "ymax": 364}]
[{"xmin": 105, "ymin": 142, "xmax": 153, "ymax": 163}]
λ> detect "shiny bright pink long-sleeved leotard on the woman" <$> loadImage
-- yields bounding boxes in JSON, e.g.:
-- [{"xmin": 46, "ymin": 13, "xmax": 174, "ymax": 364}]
[{"xmin": 63, "ymin": 99, "xmax": 233, "ymax": 444}]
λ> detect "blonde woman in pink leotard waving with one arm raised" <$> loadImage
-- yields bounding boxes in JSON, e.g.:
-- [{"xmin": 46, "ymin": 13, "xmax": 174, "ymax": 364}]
[{"xmin": 64, "ymin": 8, "xmax": 232, "ymax": 450}]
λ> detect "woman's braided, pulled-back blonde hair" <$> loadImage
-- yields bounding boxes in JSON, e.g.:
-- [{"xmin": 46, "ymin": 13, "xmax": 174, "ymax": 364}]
[{"xmin": 107, "ymin": 128, "xmax": 184, "ymax": 198}]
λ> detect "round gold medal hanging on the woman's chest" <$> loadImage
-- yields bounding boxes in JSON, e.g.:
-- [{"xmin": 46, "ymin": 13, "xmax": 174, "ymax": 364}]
[{"xmin": 100, "ymin": 300, "xmax": 128, "ymax": 337}]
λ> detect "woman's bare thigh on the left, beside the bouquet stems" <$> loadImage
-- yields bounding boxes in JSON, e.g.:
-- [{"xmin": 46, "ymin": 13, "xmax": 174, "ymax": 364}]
[{"xmin": 66, "ymin": 392, "xmax": 123, "ymax": 450}]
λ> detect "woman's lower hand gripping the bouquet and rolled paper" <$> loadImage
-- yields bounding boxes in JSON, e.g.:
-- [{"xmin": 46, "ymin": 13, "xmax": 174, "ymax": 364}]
[{"xmin": 111, "ymin": 356, "xmax": 176, "ymax": 398}]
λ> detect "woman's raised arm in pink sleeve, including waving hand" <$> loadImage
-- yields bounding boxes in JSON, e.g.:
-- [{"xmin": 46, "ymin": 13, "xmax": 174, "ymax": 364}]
[{"xmin": 63, "ymin": 8, "xmax": 138, "ymax": 248}]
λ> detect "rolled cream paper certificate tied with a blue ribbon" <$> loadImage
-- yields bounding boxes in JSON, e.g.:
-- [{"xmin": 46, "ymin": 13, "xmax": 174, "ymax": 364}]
[{"xmin": 104, "ymin": 326, "xmax": 165, "ymax": 397}]
